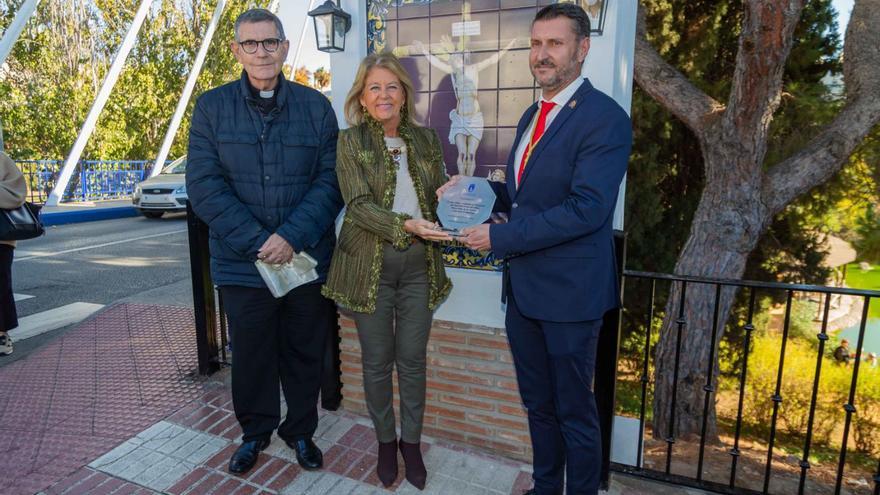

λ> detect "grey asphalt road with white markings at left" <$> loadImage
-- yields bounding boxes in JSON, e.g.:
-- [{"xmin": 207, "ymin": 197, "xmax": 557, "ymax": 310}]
[{"xmin": 0, "ymin": 214, "xmax": 192, "ymax": 366}]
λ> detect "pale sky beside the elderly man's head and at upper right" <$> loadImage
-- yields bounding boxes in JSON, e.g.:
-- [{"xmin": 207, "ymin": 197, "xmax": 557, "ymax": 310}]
[{"xmin": 278, "ymin": 0, "xmax": 854, "ymax": 72}]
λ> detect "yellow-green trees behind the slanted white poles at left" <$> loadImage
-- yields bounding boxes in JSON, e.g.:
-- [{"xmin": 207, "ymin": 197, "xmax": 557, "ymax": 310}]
[{"xmin": 0, "ymin": 0, "xmax": 329, "ymax": 160}]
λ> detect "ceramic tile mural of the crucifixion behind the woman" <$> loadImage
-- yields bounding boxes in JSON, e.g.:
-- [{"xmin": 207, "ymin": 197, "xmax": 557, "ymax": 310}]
[{"xmin": 366, "ymin": 0, "xmax": 605, "ymax": 269}]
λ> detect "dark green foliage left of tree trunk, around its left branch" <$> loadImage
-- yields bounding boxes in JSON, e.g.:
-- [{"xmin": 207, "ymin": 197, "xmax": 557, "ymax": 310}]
[{"xmin": 625, "ymin": 0, "xmax": 742, "ymax": 273}]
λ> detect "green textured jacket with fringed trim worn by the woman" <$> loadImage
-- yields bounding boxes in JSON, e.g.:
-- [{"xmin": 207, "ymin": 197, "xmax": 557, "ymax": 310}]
[{"xmin": 321, "ymin": 119, "xmax": 452, "ymax": 313}]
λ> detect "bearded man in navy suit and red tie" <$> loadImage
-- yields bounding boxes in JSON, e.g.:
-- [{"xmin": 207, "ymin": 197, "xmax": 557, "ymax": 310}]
[{"xmin": 438, "ymin": 3, "xmax": 632, "ymax": 495}]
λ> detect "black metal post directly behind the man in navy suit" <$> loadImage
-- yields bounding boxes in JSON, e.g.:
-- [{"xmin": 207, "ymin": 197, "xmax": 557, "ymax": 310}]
[{"xmin": 593, "ymin": 230, "xmax": 626, "ymax": 490}]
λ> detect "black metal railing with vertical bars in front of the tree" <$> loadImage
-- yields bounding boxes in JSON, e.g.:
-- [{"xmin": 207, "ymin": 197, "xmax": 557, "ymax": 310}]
[{"xmin": 611, "ymin": 271, "xmax": 880, "ymax": 495}]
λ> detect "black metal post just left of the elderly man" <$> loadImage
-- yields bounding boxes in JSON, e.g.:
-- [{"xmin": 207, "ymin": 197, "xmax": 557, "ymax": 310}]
[{"xmin": 186, "ymin": 201, "xmax": 220, "ymax": 375}]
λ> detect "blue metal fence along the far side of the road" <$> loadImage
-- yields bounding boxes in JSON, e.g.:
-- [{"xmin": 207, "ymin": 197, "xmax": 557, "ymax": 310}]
[{"xmin": 15, "ymin": 160, "xmax": 158, "ymax": 203}]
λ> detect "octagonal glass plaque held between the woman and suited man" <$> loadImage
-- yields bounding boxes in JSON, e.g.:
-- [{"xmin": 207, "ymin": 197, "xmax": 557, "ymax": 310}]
[{"xmin": 437, "ymin": 177, "xmax": 495, "ymax": 237}]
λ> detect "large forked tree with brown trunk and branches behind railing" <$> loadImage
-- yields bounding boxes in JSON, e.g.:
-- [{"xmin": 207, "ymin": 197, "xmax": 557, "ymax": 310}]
[{"xmin": 629, "ymin": 0, "xmax": 880, "ymax": 438}]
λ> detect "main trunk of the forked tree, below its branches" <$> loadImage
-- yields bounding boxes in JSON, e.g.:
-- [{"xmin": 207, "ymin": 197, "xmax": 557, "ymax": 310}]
[{"xmin": 654, "ymin": 146, "xmax": 769, "ymax": 440}]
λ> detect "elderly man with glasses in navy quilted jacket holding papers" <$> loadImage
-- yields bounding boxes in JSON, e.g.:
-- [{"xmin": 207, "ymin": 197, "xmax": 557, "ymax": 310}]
[{"xmin": 186, "ymin": 9, "xmax": 342, "ymax": 474}]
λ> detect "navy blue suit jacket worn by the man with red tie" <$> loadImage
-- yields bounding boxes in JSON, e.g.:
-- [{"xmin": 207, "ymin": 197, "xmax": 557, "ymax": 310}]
[{"xmin": 489, "ymin": 79, "xmax": 632, "ymax": 322}]
